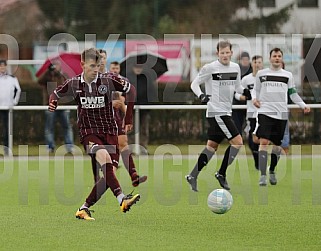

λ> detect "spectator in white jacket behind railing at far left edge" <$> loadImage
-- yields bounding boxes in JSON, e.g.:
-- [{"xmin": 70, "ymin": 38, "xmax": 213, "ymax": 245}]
[{"xmin": 0, "ymin": 59, "xmax": 21, "ymax": 155}]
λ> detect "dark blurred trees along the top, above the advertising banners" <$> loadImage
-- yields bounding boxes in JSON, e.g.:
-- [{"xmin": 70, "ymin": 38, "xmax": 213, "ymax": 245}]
[{"xmin": 37, "ymin": 0, "xmax": 291, "ymax": 39}]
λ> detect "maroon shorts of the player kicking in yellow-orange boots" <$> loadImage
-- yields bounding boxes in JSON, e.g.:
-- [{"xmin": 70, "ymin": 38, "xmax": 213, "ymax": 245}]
[{"xmin": 83, "ymin": 134, "xmax": 119, "ymax": 167}]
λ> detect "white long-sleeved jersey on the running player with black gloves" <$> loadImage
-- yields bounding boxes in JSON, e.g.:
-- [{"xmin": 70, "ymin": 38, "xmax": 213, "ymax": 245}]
[{"xmin": 191, "ymin": 60, "xmax": 244, "ymax": 117}]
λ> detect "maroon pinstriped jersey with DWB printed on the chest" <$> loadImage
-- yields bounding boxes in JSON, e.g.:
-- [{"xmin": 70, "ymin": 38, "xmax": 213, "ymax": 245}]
[{"xmin": 50, "ymin": 73, "xmax": 136, "ymax": 142}]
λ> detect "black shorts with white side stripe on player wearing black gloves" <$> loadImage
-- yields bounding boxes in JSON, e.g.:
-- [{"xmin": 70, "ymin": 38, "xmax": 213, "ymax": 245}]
[{"xmin": 207, "ymin": 115, "xmax": 239, "ymax": 144}]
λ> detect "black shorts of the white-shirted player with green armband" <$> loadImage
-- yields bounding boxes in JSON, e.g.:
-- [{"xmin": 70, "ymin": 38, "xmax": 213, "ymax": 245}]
[{"xmin": 254, "ymin": 114, "xmax": 288, "ymax": 146}]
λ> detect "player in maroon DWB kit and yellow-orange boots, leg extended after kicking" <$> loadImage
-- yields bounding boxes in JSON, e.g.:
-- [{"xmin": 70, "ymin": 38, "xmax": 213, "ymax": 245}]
[{"xmin": 48, "ymin": 48, "xmax": 140, "ymax": 220}]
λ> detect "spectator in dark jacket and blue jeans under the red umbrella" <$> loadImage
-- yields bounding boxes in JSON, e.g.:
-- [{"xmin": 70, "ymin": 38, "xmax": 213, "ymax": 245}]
[{"xmin": 38, "ymin": 61, "xmax": 74, "ymax": 153}]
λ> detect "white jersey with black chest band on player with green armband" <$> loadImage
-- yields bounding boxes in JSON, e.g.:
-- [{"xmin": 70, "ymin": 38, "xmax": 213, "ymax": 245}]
[{"xmin": 252, "ymin": 68, "xmax": 295, "ymax": 120}]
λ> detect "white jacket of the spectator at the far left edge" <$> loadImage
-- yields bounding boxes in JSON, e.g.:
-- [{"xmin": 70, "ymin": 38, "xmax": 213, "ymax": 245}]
[{"xmin": 0, "ymin": 74, "xmax": 21, "ymax": 107}]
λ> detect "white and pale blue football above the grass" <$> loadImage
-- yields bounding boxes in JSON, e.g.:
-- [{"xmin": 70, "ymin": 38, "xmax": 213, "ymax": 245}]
[{"xmin": 207, "ymin": 189, "xmax": 233, "ymax": 214}]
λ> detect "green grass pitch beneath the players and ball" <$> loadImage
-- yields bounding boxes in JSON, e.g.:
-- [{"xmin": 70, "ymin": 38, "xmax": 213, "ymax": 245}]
[{"xmin": 0, "ymin": 156, "xmax": 321, "ymax": 250}]
